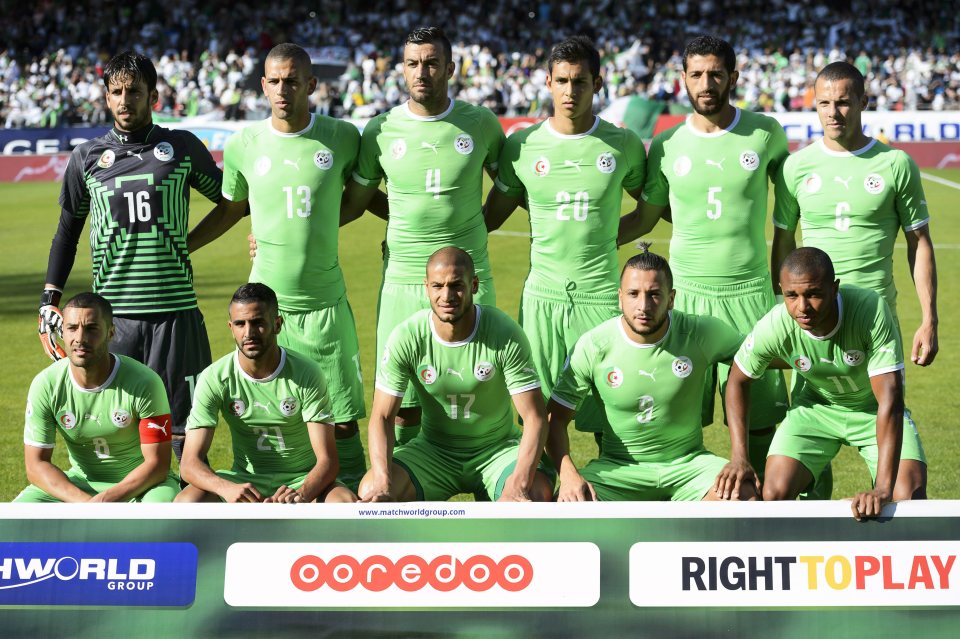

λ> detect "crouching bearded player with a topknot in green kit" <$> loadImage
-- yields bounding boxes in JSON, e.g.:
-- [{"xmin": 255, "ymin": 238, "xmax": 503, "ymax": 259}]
[{"xmin": 547, "ymin": 251, "xmax": 759, "ymax": 501}]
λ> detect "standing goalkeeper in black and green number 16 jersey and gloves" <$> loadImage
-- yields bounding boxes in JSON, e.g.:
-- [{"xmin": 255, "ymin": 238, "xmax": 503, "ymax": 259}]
[{"xmin": 40, "ymin": 52, "xmax": 222, "ymax": 458}]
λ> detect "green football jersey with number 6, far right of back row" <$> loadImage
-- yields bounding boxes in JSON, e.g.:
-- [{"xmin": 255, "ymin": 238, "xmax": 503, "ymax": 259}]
[{"xmin": 773, "ymin": 139, "xmax": 930, "ymax": 309}]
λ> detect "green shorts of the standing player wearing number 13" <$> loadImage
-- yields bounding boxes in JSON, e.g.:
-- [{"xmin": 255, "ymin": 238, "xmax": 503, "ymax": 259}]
[{"xmin": 277, "ymin": 297, "xmax": 367, "ymax": 423}]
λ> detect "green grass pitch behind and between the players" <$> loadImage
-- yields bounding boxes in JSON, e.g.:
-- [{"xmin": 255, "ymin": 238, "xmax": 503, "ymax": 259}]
[{"xmin": 0, "ymin": 169, "xmax": 960, "ymax": 501}]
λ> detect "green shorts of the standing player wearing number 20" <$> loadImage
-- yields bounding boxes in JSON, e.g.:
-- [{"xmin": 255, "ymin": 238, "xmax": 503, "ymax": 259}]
[{"xmin": 519, "ymin": 278, "xmax": 620, "ymax": 433}]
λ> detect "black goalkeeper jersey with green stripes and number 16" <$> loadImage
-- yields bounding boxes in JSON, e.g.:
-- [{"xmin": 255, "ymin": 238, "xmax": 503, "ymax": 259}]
[{"xmin": 53, "ymin": 125, "xmax": 223, "ymax": 315}]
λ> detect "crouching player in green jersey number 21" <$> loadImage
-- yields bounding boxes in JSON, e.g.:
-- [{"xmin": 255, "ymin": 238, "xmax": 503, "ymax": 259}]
[{"xmin": 177, "ymin": 284, "xmax": 356, "ymax": 503}]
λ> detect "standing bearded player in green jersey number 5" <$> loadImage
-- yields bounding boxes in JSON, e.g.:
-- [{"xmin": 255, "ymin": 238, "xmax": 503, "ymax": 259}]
[{"xmin": 618, "ymin": 35, "xmax": 787, "ymax": 482}]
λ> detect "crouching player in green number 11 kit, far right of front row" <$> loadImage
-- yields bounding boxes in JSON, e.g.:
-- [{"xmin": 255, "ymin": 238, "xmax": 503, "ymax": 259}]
[{"xmin": 727, "ymin": 247, "xmax": 927, "ymax": 520}]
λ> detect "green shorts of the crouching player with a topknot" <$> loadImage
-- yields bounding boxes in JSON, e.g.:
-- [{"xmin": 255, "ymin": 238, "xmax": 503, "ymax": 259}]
[{"xmin": 580, "ymin": 450, "xmax": 727, "ymax": 501}]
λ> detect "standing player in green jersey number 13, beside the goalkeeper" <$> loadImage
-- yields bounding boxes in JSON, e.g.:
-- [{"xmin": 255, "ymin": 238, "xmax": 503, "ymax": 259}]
[{"xmin": 190, "ymin": 43, "xmax": 366, "ymax": 490}]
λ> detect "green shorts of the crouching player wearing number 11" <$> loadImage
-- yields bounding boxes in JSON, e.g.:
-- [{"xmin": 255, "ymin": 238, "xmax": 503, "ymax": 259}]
[{"xmin": 768, "ymin": 402, "xmax": 927, "ymax": 480}]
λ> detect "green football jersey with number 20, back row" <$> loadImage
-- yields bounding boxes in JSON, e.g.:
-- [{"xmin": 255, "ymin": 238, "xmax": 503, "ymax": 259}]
[{"xmin": 494, "ymin": 118, "xmax": 646, "ymax": 295}]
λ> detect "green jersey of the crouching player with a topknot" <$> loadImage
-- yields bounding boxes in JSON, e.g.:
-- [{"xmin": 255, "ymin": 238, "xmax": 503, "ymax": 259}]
[{"xmin": 553, "ymin": 310, "xmax": 742, "ymax": 462}]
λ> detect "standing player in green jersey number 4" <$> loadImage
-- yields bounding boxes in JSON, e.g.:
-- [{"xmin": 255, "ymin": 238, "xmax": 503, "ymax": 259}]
[{"xmin": 344, "ymin": 27, "xmax": 504, "ymax": 442}]
